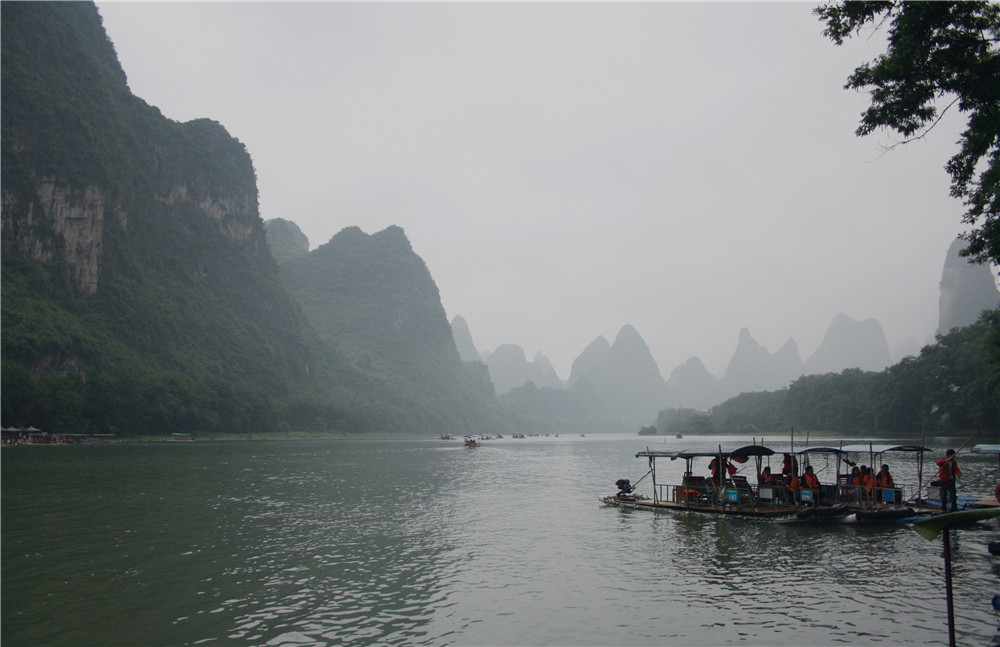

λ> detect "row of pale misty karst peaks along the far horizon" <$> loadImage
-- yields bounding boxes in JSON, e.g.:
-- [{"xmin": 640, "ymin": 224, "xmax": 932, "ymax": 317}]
[{"xmin": 452, "ymin": 235, "xmax": 1000, "ymax": 421}]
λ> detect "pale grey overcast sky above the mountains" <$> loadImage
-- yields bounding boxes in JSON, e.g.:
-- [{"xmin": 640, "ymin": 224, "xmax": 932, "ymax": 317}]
[{"xmin": 98, "ymin": 2, "xmax": 964, "ymax": 379}]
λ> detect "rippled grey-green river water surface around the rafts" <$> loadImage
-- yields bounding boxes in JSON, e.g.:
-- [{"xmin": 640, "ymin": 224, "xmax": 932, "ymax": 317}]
[{"xmin": 0, "ymin": 437, "xmax": 1000, "ymax": 645}]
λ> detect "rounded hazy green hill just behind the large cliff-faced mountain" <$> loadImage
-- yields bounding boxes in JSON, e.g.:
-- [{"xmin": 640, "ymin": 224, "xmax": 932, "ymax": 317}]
[{"xmin": 281, "ymin": 227, "xmax": 502, "ymax": 433}]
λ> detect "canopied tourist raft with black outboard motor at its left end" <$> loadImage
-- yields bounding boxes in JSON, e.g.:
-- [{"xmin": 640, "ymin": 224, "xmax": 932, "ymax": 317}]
[{"xmin": 600, "ymin": 444, "xmax": 850, "ymax": 521}]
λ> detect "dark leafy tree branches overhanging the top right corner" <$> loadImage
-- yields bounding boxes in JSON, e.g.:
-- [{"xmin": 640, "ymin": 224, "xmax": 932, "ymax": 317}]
[{"xmin": 815, "ymin": 1, "xmax": 1000, "ymax": 263}]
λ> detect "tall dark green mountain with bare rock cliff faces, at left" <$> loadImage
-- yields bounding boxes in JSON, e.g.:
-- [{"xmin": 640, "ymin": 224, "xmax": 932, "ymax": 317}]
[{"xmin": 0, "ymin": 2, "xmax": 504, "ymax": 434}]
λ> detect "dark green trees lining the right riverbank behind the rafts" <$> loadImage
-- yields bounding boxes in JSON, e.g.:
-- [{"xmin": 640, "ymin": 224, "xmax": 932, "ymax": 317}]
[{"xmin": 639, "ymin": 310, "xmax": 1000, "ymax": 436}]
